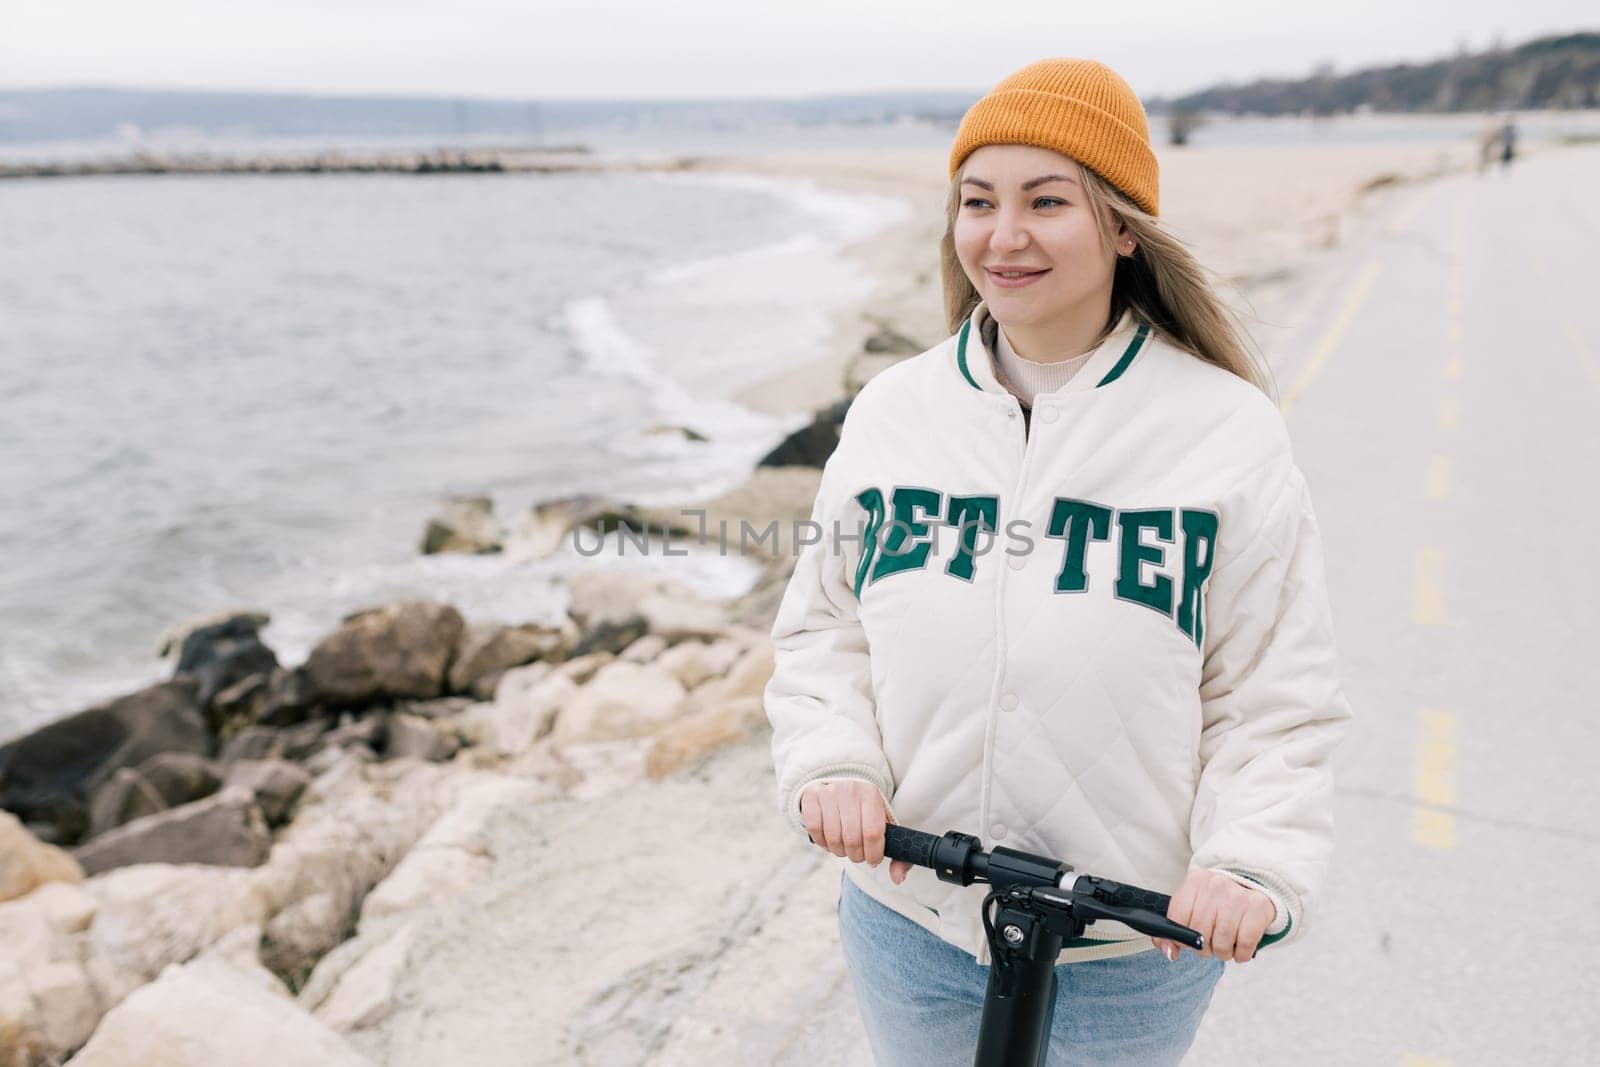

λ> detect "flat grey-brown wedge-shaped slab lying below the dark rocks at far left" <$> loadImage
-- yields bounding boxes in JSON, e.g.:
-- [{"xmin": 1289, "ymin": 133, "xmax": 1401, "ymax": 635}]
[{"xmin": 74, "ymin": 789, "xmax": 272, "ymax": 875}]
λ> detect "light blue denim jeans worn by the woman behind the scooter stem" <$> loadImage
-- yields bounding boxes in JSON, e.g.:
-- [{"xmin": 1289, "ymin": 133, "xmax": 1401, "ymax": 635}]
[{"xmin": 838, "ymin": 861, "xmax": 1226, "ymax": 1067}]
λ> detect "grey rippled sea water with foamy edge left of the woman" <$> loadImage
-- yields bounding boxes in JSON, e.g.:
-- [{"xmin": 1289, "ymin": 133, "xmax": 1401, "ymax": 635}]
[{"xmin": 0, "ymin": 164, "xmax": 906, "ymax": 739}]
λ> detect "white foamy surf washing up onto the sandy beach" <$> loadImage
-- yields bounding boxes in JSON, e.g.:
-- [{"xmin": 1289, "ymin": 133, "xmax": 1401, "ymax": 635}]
[{"xmin": 557, "ymin": 165, "xmax": 910, "ymax": 518}]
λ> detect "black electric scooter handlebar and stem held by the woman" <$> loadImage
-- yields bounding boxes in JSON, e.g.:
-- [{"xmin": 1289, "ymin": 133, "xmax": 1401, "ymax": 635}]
[{"xmin": 883, "ymin": 822, "xmax": 1275, "ymax": 1067}]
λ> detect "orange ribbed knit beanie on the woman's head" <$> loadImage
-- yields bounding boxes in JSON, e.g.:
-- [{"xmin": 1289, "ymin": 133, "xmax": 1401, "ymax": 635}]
[{"xmin": 950, "ymin": 59, "xmax": 1160, "ymax": 214}]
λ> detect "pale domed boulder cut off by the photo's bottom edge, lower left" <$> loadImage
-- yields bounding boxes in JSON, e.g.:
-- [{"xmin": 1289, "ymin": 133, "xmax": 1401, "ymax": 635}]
[{"xmin": 72, "ymin": 957, "xmax": 373, "ymax": 1067}]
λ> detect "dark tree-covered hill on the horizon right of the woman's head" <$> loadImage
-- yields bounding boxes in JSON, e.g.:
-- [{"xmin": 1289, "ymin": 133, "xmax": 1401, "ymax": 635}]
[{"xmin": 1146, "ymin": 34, "xmax": 1600, "ymax": 115}]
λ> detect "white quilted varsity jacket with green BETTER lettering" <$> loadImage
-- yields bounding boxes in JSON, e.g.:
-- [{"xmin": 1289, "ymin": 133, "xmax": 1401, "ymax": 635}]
[{"xmin": 765, "ymin": 304, "xmax": 1350, "ymax": 963}]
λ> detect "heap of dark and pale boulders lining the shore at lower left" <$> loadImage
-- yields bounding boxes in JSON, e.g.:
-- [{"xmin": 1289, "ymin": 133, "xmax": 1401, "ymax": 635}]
[{"xmin": 0, "ymin": 569, "xmax": 771, "ymax": 1067}]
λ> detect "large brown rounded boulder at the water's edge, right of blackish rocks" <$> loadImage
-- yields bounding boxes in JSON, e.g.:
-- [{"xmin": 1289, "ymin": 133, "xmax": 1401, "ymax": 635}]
[{"xmin": 306, "ymin": 601, "xmax": 466, "ymax": 707}]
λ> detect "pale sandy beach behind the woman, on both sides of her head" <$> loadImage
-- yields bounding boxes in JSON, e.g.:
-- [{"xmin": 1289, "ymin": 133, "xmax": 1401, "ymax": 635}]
[{"xmin": 713, "ymin": 141, "xmax": 1484, "ymax": 425}]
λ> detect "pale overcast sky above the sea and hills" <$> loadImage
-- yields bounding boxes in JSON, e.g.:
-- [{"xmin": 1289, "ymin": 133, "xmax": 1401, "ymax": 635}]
[{"xmin": 0, "ymin": 0, "xmax": 1600, "ymax": 98}]
